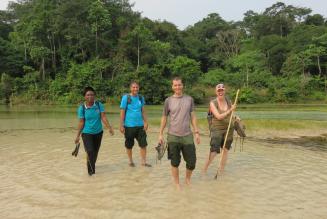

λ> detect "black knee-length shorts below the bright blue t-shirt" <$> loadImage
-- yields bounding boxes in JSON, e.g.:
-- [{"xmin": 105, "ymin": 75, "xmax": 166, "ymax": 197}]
[{"xmin": 125, "ymin": 126, "xmax": 148, "ymax": 149}]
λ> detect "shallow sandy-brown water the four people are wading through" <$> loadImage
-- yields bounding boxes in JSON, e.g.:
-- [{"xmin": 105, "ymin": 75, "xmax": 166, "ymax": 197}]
[{"xmin": 0, "ymin": 105, "xmax": 327, "ymax": 219}]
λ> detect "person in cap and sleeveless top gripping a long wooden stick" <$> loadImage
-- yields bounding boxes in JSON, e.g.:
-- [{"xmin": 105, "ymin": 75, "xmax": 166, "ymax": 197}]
[{"xmin": 203, "ymin": 83, "xmax": 235, "ymax": 173}]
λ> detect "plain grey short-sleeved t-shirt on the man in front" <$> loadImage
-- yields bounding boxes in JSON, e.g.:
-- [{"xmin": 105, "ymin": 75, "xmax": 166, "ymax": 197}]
[{"xmin": 163, "ymin": 95, "xmax": 194, "ymax": 136}]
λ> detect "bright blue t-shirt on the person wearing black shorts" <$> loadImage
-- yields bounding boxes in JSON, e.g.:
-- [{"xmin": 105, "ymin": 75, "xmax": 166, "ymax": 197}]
[{"xmin": 120, "ymin": 95, "xmax": 145, "ymax": 127}]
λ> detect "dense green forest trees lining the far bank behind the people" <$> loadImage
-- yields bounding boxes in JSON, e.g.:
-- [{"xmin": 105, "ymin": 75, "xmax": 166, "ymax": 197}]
[{"xmin": 0, "ymin": 0, "xmax": 327, "ymax": 104}]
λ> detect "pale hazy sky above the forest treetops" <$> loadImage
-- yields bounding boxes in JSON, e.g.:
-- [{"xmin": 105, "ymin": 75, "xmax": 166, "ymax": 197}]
[{"xmin": 0, "ymin": 0, "xmax": 327, "ymax": 30}]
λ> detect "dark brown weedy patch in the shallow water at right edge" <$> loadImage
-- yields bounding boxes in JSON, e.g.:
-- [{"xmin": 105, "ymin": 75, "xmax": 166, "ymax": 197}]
[{"xmin": 253, "ymin": 133, "xmax": 327, "ymax": 152}]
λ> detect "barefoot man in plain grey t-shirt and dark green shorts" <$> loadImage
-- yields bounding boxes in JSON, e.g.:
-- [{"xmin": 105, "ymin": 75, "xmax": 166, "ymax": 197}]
[{"xmin": 159, "ymin": 77, "xmax": 200, "ymax": 189}]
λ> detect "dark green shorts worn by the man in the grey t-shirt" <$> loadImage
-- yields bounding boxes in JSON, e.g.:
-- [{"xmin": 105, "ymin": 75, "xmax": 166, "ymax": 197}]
[{"xmin": 167, "ymin": 134, "xmax": 196, "ymax": 170}]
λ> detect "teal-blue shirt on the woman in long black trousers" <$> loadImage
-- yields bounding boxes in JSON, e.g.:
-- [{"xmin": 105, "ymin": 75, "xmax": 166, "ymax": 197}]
[{"xmin": 77, "ymin": 102, "xmax": 104, "ymax": 134}]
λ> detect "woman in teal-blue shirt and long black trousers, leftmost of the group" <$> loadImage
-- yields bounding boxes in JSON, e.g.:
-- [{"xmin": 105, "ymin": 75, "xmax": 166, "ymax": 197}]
[{"xmin": 75, "ymin": 87, "xmax": 114, "ymax": 176}]
